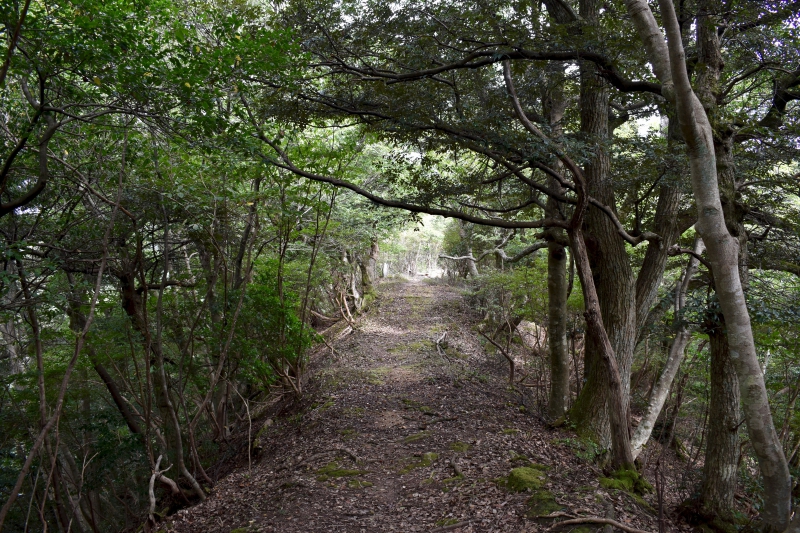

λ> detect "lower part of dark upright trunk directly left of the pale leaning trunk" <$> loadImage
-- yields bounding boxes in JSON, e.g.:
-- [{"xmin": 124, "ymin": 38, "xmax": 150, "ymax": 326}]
[{"xmin": 700, "ymin": 323, "xmax": 740, "ymax": 520}]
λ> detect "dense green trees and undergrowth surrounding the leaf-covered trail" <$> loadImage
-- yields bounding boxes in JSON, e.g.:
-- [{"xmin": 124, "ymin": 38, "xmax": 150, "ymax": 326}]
[{"xmin": 0, "ymin": 0, "xmax": 800, "ymax": 533}]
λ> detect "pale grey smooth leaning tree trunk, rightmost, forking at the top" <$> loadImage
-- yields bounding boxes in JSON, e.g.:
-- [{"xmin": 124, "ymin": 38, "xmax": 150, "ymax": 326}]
[{"xmin": 625, "ymin": 0, "xmax": 791, "ymax": 531}]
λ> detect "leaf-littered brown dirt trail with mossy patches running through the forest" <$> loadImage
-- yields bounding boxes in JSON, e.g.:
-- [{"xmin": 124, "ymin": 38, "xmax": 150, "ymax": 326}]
[{"xmin": 166, "ymin": 280, "xmax": 676, "ymax": 533}]
